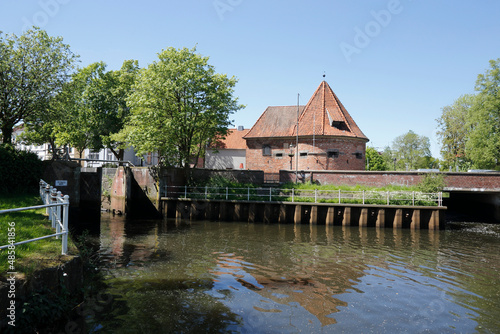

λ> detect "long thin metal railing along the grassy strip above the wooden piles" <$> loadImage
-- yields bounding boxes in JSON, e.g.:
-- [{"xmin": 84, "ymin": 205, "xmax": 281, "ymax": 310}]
[{"xmin": 162, "ymin": 186, "xmax": 443, "ymax": 206}]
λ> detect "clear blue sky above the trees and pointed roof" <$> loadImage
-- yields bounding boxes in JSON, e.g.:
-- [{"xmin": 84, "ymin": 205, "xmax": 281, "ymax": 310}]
[{"xmin": 0, "ymin": 0, "xmax": 500, "ymax": 157}]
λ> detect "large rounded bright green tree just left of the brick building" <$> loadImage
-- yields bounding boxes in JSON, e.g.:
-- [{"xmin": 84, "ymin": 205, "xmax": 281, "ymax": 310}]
[{"xmin": 113, "ymin": 48, "xmax": 243, "ymax": 172}]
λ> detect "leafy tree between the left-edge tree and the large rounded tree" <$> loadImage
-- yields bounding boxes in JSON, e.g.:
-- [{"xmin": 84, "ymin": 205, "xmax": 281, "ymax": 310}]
[{"xmin": 56, "ymin": 60, "xmax": 139, "ymax": 160}]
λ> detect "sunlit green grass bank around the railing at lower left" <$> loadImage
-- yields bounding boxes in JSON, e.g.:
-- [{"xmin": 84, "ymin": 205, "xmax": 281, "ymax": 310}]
[{"xmin": 0, "ymin": 194, "xmax": 78, "ymax": 281}]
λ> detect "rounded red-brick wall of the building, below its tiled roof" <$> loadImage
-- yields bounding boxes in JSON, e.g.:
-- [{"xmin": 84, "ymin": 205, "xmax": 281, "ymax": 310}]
[{"xmin": 246, "ymin": 137, "xmax": 366, "ymax": 173}]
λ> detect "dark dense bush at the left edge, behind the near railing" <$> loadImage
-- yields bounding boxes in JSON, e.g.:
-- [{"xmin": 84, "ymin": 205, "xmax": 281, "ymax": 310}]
[{"xmin": 0, "ymin": 144, "xmax": 43, "ymax": 193}]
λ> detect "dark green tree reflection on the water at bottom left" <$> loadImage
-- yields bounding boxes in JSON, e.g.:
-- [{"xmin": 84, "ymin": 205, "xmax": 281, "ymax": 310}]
[{"xmin": 94, "ymin": 278, "xmax": 243, "ymax": 333}]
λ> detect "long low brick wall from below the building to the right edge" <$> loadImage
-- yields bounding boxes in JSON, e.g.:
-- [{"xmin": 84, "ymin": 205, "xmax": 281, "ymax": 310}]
[{"xmin": 280, "ymin": 169, "xmax": 500, "ymax": 191}]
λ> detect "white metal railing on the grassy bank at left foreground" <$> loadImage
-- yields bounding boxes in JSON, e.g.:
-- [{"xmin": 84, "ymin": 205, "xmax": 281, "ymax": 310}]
[{"xmin": 0, "ymin": 180, "xmax": 69, "ymax": 255}]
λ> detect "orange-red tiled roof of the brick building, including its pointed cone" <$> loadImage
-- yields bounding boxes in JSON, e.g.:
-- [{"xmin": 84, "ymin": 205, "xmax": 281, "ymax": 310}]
[{"xmin": 245, "ymin": 81, "xmax": 368, "ymax": 141}]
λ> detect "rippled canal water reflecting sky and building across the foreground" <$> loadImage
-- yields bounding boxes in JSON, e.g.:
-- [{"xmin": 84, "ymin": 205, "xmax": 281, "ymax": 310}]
[{"xmin": 84, "ymin": 214, "xmax": 500, "ymax": 333}]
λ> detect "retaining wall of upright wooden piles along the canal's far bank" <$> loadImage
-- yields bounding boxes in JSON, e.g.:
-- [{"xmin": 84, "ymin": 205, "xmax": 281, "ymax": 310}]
[{"xmin": 161, "ymin": 198, "xmax": 446, "ymax": 230}]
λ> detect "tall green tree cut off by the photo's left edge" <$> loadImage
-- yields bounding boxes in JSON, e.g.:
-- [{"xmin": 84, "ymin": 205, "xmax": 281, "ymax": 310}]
[{"xmin": 0, "ymin": 28, "xmax": 77, "ymax": 143}]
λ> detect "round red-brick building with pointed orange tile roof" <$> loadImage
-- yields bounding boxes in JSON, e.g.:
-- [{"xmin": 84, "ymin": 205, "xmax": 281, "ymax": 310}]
[{"xmin": 243, "ymin": 81, "xmax": 368, "ymax": 173}]
